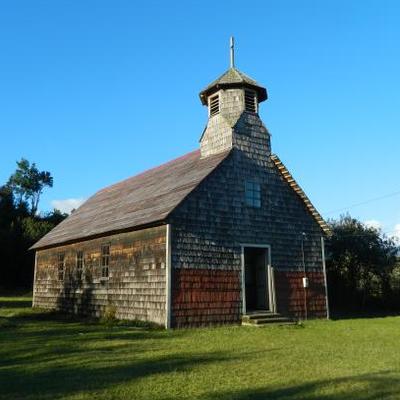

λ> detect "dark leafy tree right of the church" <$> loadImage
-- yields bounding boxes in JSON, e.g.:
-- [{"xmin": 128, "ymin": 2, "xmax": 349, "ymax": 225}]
[{"xmin": 327, "ymin": 215, "xmax": 399, "ymax": 308}]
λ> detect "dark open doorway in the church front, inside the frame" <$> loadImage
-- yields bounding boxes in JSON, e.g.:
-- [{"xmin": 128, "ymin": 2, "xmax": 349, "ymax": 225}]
[{"xmin": 244, "ymin": 247, "xmax": 269, "ymax": 312}]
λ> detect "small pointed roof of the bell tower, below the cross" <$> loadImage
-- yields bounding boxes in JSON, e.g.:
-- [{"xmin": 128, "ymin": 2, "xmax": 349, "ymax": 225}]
[{"xmin": 200, "ymin": 67, "xmax": 268, "ymax": 105}]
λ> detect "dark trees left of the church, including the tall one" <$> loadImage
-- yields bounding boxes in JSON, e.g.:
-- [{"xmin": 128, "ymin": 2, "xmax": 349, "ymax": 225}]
[{"xmin": 0, "ymin": 159, "xmax": 67, "ymax": 290}]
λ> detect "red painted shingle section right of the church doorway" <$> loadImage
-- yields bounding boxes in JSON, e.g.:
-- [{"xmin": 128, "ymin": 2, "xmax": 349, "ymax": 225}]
[{"xmin": 275, "ymin": 271, "xmax": 326, "ymax": 319}]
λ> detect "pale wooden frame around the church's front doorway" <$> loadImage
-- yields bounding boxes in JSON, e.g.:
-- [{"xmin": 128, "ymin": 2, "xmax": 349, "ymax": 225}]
[{"xmin": 240, "ymin": 243, "xmax": 276, "ymax": 315}]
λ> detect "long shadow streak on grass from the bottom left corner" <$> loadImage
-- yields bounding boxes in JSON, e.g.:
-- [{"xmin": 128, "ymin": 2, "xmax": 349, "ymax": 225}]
[{"xmin": 1, "ymin": 353, "xmax": 241, "ymax": 399}]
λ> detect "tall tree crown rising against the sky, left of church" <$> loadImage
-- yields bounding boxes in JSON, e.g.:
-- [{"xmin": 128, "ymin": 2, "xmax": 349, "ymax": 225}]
[{"xmin": 8, "ymin": 158, "xmax": 53, "ymax": 216}]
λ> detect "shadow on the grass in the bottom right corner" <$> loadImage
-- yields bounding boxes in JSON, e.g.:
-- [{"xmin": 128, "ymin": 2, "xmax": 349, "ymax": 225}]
[{"xmin": 201, "ymin": 371, "xmax": 400, "ymax": 400}]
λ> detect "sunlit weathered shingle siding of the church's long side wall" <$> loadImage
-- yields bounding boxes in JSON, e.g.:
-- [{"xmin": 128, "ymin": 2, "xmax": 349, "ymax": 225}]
[{"xmin": 33, "ymin": 226, "xmax": 166, "ymax": 324}]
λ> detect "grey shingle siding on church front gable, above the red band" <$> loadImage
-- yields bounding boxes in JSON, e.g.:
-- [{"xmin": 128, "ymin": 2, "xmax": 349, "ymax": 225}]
[{"xmin": 169, "ymin": 113, "xmax": 324, "ymax": 325}]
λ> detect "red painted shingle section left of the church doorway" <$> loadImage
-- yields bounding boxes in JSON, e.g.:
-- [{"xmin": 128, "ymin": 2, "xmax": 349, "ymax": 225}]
[{"xmin": 171, "ymin": 268, "xmax": 242, "ymax": 328}]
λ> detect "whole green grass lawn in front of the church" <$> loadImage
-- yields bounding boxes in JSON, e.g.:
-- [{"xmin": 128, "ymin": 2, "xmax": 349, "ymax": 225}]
[{"xmin": 0, "ymin": 297, "xmax": 400, "ymax": 400}]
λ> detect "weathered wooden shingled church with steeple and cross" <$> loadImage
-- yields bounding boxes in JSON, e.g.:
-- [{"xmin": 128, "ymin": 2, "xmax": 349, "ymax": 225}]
[{"xmin": 32, "ymin": 39, "xmax": 329, "ymax": 328}]
